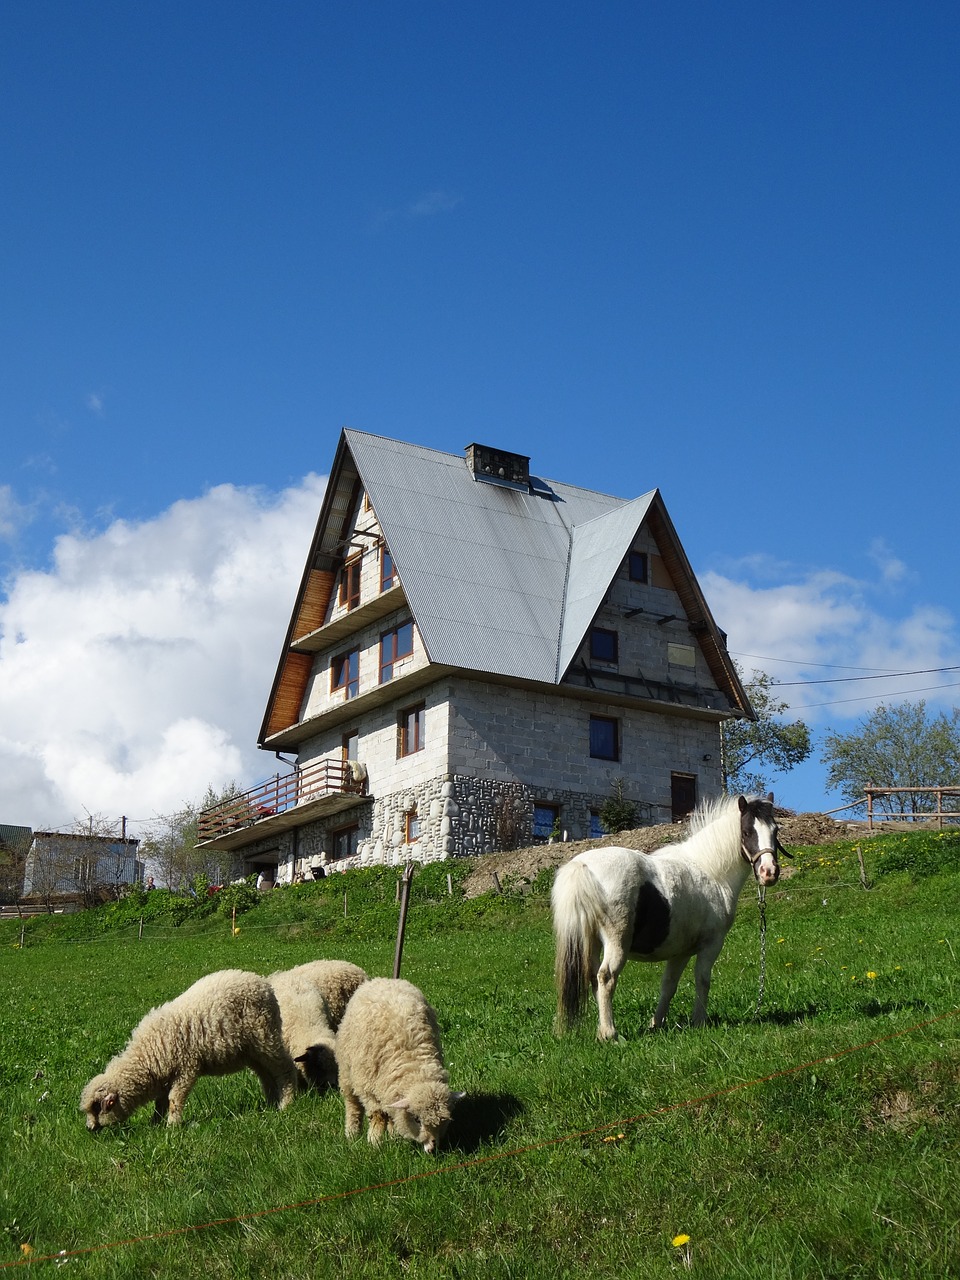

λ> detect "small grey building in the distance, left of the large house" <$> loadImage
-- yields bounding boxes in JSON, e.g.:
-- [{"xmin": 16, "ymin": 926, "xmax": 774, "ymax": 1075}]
[{"xmin": 23, "ymin": 831, "xmax": 143, "ymax": 906}]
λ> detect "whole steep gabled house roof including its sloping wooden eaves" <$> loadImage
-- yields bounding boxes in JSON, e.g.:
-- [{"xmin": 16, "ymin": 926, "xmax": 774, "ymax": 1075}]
[{"xmin": 260, "ymin": 429, "xmax": 753, "ymax": 745}]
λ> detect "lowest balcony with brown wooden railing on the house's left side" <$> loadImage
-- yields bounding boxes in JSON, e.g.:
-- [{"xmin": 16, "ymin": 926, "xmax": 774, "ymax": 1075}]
[{"xmin": 197, "ymin": 759, "xmax": 367, "ymax": 849}]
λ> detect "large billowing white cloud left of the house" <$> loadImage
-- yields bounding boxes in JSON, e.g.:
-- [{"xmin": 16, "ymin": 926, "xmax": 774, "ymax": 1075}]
[{"xmin": 0, "ymin": 475, "xmax": 325, "ymax": 827}]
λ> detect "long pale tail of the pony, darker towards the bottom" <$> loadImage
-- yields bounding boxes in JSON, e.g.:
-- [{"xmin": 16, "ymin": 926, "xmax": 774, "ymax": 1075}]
[{"xmin": 550, "ymin": 859, "xmax": 607, "ymax": 1036}]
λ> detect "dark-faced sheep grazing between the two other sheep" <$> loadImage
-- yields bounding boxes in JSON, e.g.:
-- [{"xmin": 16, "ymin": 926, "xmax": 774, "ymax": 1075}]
[{"xmin": 268, "ymin": 960, "xmax": 366, "ymax": 1089}]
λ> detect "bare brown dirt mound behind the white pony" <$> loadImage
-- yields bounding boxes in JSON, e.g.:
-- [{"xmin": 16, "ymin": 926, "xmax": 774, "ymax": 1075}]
[{"xmin": 463, "ymin": 813, "xmax": 868, "ymax": 897}]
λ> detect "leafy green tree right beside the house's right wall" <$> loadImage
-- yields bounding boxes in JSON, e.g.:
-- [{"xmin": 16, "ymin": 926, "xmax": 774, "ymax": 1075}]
[{"xmin": 721, "ymin": 671, "xmax": 813, "ymax": 795}]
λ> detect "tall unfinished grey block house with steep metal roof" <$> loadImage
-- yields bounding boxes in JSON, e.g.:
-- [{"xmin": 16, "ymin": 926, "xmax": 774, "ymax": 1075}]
[{"xmin": 200, "ymin": 430, "xmax": 754, "ymax": 879}]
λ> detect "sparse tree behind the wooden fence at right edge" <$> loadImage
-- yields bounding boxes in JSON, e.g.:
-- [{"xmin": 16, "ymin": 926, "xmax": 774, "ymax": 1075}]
[{"xmin": 822, "ymin": 700, "xmax": 960, "ymax": 813}]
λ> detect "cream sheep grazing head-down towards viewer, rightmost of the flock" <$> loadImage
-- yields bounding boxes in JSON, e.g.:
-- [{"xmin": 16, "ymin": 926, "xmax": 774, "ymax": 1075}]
[{"xmin": 337, "ymin": 978, "xmax": 463, "ymax": 1153}]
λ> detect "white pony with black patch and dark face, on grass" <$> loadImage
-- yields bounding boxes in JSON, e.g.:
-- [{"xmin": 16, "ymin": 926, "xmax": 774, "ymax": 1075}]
[{"xmin": 552, "ymin": 794, "xmax": 786, "ymax": 1039}]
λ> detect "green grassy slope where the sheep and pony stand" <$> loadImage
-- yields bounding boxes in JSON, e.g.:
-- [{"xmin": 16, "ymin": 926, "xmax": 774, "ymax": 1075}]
[{"xmin": 0, "ymin": 835, "xmax": 960, "ymax": 1280}]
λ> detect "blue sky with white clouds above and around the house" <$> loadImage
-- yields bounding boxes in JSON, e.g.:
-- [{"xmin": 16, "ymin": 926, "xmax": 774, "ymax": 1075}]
[{"xmin": 0, "ymin": 0, "xmax": 960, "ymax": 827}]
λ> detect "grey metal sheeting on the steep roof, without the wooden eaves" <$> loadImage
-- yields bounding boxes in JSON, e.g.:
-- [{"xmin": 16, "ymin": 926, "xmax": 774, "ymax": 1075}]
[{"xmin": 343, "ymin": 430, "xmax": 632, "ymax": 684}]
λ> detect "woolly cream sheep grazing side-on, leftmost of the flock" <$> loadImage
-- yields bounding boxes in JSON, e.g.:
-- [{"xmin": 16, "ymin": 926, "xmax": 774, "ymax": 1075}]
[{"xmin": 81, "ymin": 969, "xmax": 297, "ymax": 1132}]
